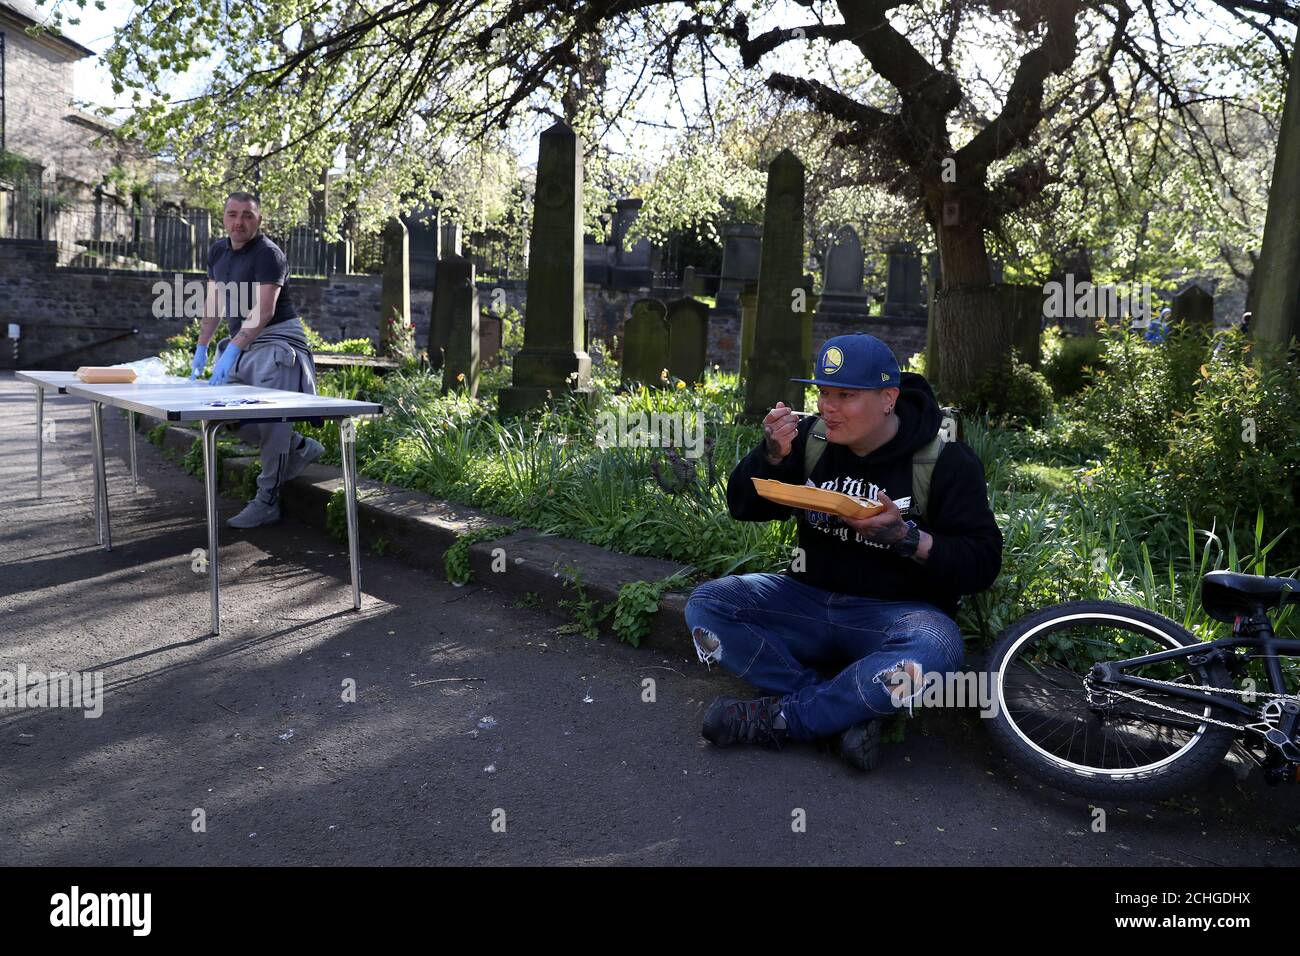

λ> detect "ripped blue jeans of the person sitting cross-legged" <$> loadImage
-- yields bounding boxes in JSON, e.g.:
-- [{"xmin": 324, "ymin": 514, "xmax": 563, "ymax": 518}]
[{"xmin": 686, "ymin": 574, "xmax": 965, "ymax": 740}]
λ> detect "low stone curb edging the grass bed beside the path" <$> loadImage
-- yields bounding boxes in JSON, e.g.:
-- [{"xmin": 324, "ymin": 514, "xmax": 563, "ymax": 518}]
[{"xmin": 138, "ymin": 416, "xmax": 693, "ymax": 653}]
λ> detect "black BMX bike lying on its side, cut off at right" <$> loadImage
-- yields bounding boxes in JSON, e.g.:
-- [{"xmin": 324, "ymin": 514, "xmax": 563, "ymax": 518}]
[{"xmin": 987, "ymin": 571, "xmax": 1300, "ymax": 800}]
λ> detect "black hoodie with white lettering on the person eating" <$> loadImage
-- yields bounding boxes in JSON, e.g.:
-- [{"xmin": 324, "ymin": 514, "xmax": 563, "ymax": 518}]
[{"xmin": 727, "ymin": 372, "xmax": 1002, "ymax": 617}]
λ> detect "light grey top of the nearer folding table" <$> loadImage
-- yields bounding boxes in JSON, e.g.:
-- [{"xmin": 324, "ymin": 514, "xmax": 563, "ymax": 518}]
[{"xmin": 64, "ymin": 380, "xmax": 384, "ymax": 421}]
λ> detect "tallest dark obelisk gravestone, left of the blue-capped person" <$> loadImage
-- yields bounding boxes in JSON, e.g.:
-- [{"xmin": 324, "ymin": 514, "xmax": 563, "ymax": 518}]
[{"xmin": 499, "ymin": 122, "xmax": 592, "ymax": 416}]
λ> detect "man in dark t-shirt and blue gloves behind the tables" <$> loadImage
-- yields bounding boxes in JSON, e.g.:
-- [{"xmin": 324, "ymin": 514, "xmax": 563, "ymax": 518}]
[{"xmin": 190, "ymin": 193, "xmax": 324, "ymax": 528}]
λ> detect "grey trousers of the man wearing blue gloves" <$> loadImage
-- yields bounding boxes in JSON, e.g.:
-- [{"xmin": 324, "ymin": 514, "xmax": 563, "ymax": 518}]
[{"xmin": 216, "ymin": 319, "xmax": 316, "ymax": 505}]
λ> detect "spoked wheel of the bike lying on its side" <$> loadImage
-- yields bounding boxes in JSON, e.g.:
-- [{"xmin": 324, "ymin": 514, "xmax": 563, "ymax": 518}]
[{"xmin": 988, "ymin": 601, "xmax": 1236, "ymax": 800}]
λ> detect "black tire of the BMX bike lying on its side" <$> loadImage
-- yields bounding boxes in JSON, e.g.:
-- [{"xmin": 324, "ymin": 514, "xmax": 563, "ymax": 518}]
[{"xmin": 985, "ymin": 601, "xmax": 1238, "ymax": 800}]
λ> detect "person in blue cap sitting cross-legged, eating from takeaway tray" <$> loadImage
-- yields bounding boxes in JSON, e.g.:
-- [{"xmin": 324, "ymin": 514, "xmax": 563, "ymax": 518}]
[{"xmin": 686, "ymin": 333, "xmax": 1002, "ymax": 770}]
